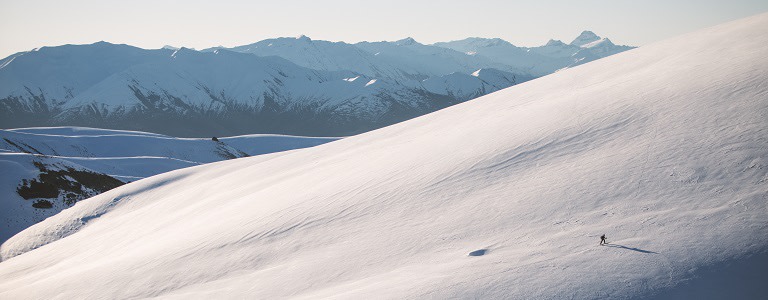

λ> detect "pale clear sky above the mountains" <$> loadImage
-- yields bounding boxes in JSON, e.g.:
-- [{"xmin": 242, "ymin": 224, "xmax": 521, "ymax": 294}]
[{"xmin": 0, "ymin": 0, "xmax": 768, "ymax": 57}]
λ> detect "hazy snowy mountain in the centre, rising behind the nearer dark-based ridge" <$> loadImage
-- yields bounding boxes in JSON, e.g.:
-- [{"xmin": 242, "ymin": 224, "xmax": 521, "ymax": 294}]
[{"xmin": 203, "ymin": 35, "xmax": 531, "ymax": 81}]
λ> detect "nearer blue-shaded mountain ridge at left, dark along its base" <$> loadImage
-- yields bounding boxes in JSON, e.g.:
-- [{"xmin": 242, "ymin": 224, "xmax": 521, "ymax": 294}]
[{"xmin": 0, "ymin": 42, "xmax": 528, "ymax": 137}]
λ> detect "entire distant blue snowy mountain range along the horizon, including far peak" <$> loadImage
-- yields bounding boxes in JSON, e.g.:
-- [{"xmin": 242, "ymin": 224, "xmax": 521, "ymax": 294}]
[{"xmin": 0, "ymin": 31, "xmax": 632, "ymax": 137}]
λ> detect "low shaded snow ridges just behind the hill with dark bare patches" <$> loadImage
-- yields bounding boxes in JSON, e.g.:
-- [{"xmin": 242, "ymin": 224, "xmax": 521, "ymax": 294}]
[{"xmin": 0, "ymin": 127, "xmax": 339, "ymax": 165}]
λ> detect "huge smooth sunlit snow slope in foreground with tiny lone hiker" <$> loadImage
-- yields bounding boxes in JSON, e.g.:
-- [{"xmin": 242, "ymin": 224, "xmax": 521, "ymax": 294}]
[{"xmin": 0, "ymin": 14, "xmax": 768, "ymax": 299}]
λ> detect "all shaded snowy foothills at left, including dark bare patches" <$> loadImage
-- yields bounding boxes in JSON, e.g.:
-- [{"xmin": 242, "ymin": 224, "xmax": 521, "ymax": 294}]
[{"xmin": 0, "ymin": 127, "xmax": 336, "ymax": 243}]
